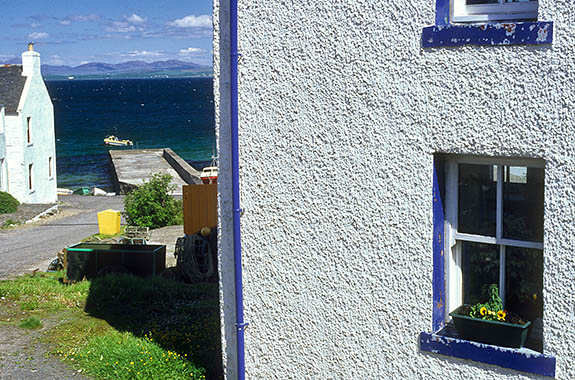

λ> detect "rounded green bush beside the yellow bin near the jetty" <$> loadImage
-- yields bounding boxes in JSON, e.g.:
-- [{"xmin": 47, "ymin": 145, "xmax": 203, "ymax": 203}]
[{"xmin": 124, "ymin": 173, "xmax": 183, "ymax": 228}]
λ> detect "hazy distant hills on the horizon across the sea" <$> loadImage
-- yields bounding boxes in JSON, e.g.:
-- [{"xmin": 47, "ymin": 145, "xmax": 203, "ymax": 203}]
[{"xmin": 42, "ymin": 59, "xmax": 212, "ymax": 77}]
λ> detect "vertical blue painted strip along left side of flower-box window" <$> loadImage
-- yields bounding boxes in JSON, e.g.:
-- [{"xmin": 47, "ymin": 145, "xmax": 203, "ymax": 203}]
[{"xmin": 433, "ymin": 162, "xmax": 445, "ymax": 331}]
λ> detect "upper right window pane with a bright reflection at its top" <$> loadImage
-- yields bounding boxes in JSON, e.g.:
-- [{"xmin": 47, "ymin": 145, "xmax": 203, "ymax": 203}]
[{"xmin": 503, "ymin": 166, "xmax": 544, "ymax": 242}]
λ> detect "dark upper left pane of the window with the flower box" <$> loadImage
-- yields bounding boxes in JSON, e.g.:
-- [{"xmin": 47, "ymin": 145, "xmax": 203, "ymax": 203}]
[{"xmin": 457, "ymin": 164, "xmax": 497, "ymax": 236}]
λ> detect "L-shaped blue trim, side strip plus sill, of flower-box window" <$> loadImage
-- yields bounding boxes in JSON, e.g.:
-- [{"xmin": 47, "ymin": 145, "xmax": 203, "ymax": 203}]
[{"xmin": 419, "ymin": 155, "xmax": 556, "ymax": 377}]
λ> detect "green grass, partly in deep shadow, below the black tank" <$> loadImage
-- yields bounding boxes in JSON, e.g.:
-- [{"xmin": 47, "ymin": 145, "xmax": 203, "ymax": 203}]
[{"xmin": 0, "ymin": 273, "xmax": 223, "ymax": 379}]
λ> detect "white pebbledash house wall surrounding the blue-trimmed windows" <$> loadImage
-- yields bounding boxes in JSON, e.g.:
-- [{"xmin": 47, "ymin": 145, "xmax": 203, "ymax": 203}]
[{"xmin": 214, "ymin": 0, "xmax": 575, "ymax": 380}]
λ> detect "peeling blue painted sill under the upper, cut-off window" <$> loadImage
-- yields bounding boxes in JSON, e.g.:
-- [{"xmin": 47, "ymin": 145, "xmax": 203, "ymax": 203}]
[{"xmin": 421, "ymin": 20, "xmax": 553, "ymax": 48}]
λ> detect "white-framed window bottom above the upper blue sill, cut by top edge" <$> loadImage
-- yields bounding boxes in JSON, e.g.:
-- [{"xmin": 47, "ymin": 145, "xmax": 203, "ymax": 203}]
[{"xmin": 450, "ymin": 0, "xmax": 539, "ymax": 22}]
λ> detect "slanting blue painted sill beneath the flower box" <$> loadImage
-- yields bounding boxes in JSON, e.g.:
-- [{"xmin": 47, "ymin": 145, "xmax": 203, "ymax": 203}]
[{"xmin": 419, "ymin": 332, "xmax": 556, "ymax": 377}]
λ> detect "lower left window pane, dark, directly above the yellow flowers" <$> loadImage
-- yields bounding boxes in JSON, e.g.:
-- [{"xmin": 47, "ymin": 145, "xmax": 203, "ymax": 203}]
[{"xmin": 459, "ymin": 241, "xmax": 499, "ymax": 305}]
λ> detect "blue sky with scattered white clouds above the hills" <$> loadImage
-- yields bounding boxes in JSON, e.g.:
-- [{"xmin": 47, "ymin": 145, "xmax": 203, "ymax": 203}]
[{"xmin": 0, "ymin": 0, "xmax": 212, "ymax": 66}]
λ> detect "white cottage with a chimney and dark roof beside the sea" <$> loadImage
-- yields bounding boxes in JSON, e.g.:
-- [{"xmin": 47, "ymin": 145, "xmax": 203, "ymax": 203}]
[{"xmin": 0, "ymin": 44, "xmax": 57, "ymax": 203}]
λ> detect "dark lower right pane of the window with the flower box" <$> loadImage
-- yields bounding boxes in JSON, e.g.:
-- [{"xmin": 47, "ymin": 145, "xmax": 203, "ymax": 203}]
[{"xmin": 505, "ymin": 247, "xmax": 543, "ymax": 321}]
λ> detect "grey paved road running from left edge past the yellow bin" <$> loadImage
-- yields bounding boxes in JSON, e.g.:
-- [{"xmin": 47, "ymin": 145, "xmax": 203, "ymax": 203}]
[{"xmin": 0, "ymin": 196, "xmax": 124, "ymax": 278}]
